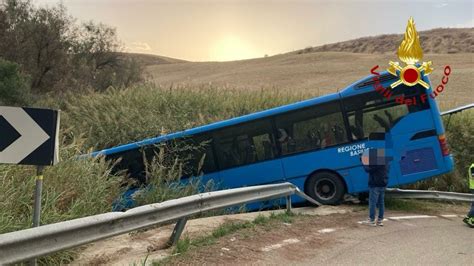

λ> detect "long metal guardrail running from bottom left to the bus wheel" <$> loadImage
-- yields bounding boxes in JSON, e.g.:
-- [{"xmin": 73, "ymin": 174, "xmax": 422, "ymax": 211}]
[{"xmin": 0, "ymin": 183, "xmax": 321, "ymax": 265}]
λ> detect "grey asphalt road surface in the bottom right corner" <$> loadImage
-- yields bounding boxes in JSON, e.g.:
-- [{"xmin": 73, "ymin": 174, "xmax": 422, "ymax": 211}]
[{"xmin": 296, "ymin": 215, "xmax": 474, "ymax": 265}]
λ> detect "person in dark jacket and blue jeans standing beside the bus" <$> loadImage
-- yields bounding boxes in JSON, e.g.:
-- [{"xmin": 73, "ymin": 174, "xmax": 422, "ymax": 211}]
[{"xmin": 361, "ymin": 149, "xmax": 389, "ymax": 226}]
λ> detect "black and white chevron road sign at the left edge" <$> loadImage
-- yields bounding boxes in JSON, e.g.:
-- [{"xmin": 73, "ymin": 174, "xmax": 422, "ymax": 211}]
[{"xmin": 0, "ymin": 106, "xmax": 59, "ymax": 165}]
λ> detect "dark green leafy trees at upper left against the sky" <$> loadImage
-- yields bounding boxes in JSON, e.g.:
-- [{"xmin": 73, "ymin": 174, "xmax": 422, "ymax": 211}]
[{"xmin": 0, "ymin": 0, "xmax": 143, "ymax": 105}]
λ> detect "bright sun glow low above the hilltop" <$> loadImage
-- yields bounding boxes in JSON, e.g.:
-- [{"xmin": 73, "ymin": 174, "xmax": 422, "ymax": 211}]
[{"xmin": 209, "ymin": 35, "xmax": 262, "ymax": 61}]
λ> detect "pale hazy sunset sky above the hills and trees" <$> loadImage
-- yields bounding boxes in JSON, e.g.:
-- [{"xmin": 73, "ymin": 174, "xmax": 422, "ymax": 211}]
[{"xmin": 32, "ymin": 0, "xmax": 474, "ymax": 61}]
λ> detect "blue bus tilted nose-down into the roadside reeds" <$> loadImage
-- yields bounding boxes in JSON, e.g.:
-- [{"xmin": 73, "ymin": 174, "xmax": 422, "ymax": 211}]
[{"xmin": 92, "ymin": 72, "xmax": 454, "ymax": 204}]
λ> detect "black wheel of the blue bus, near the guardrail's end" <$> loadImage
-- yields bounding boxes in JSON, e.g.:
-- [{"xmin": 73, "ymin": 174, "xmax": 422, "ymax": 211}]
[{"xmin": 306, "ymin": 172, "xmax": 345, "ymax": 205}]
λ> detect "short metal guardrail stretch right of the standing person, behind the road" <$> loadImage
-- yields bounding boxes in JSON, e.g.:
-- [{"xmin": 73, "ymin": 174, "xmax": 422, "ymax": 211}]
[{"xmin": 386, "ymin": 188, "xmax": 474, "ymax": 202}]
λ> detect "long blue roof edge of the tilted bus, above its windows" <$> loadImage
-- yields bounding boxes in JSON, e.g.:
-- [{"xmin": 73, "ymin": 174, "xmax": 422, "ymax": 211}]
[{"xmin": 89, "ymin": 72, "xmax": 387, "ymax": 156}]
